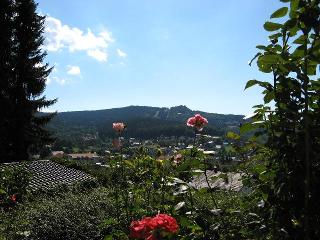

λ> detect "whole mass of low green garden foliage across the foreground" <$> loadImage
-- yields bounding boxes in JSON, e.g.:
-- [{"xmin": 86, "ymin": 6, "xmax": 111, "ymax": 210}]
[{"xmin": 0, "ymin": 145, "xmax": 268, "ymax": 240}]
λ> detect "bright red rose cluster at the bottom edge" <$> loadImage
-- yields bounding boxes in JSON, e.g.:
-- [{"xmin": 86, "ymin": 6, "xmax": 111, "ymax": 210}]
[{"xmin": 130, "ymin": 214, "xmax": 179, "ymax": 240}]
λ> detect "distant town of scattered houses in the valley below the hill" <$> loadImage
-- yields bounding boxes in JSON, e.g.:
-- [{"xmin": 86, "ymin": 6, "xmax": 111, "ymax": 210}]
[{"xmin": 43, "ymin": 134, "xmax": 240, "ymax": 172}]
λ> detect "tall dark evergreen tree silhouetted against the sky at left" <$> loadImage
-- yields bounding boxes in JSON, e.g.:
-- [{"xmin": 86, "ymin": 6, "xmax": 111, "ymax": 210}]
[{"xmin": 1, "ymin": 0, "xmax": 56, "ymax": 161}]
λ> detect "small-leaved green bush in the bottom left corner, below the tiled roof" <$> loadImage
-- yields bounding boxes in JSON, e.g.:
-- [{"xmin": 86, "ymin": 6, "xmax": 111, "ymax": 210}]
[{"xmin": 0, "ymin": 188, "xmax": 115, "ymax": 240}]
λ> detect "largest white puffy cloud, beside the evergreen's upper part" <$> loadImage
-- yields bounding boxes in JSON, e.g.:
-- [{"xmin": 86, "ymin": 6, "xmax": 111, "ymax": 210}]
[{"xmin": 45, "ymin": 16, "xmax": 114, "ymax": 61}]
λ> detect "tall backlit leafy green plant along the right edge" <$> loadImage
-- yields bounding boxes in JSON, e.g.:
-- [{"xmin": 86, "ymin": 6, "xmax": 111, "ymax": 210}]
[{"xmin": 246, "ymin": 0, "xmax": 320, "ymax": 239}]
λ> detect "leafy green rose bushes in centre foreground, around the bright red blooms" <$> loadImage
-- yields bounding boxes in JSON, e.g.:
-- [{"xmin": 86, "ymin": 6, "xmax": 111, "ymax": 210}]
[{"xmin": 88, "ymin": 144, "xmax": 267, "ymax": 239}]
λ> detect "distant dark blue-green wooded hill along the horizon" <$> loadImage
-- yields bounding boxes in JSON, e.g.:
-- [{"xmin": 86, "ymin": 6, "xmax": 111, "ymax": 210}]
[{"xmin": 48, "ymin": 106, "xmax": 244, "ymax": 144}]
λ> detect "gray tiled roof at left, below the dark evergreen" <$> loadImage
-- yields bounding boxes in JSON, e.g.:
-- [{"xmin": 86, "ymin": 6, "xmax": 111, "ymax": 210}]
[{"xmin": 0, "ymin": 160, "xmax": 95, "ymax": 191}]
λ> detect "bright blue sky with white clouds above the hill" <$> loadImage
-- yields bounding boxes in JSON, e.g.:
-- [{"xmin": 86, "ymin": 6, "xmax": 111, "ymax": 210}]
[{"xmin": 38, "ymin": 0, "xmax": 284, "ymax": 114}]
